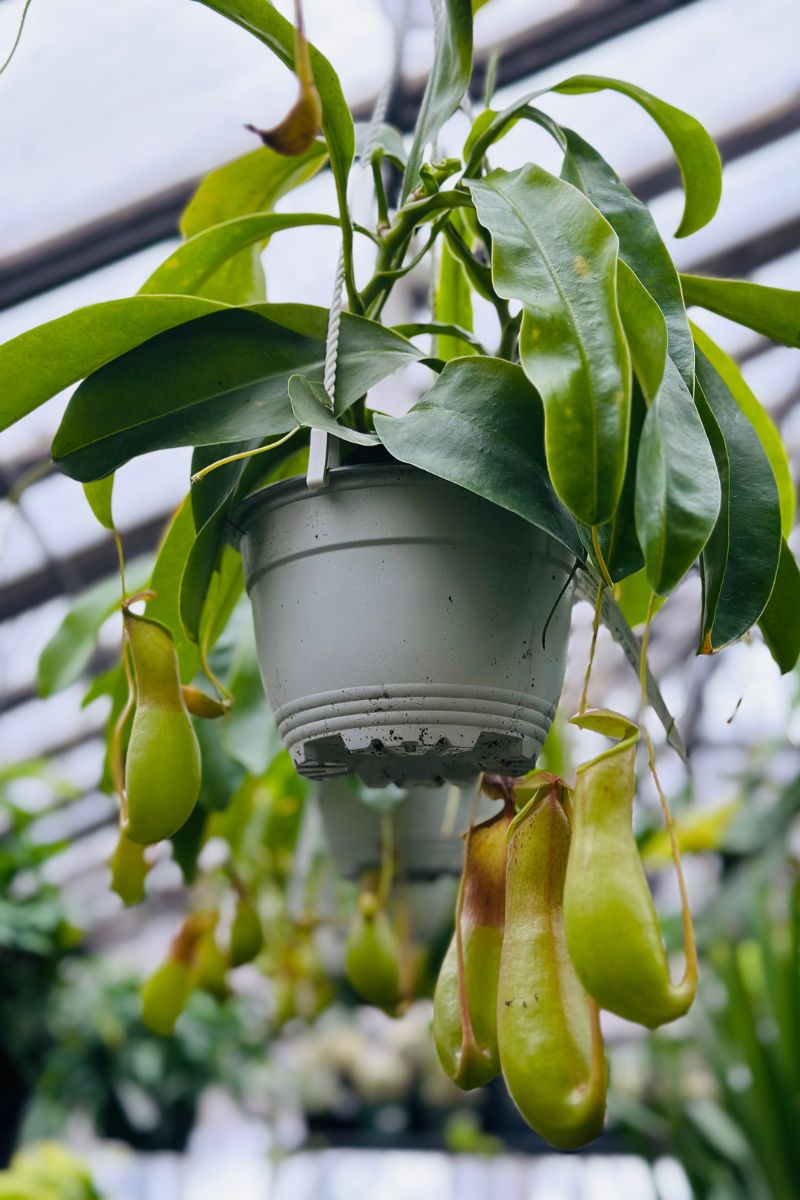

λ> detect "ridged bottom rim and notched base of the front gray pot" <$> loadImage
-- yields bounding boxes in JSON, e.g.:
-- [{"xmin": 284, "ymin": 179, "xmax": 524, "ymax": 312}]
[{"xmin": 276, "ymin": 683, "xmax": 554, "ymax": 787}]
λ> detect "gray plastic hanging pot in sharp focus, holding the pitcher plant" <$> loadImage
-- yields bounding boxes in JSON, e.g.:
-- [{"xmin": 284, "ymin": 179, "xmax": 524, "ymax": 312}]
[{"xmin": 231, "ymin": 464, "xmax": 572, "ymax": 787}]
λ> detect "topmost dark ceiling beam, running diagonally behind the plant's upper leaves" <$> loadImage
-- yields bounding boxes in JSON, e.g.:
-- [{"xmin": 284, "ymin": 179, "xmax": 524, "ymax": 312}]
[{"xmin": 0, "ymin": 0, "xmax": 698, "ymax": 310}]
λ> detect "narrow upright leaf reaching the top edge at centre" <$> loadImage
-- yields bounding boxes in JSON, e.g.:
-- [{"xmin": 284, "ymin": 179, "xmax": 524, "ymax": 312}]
[{"xmin": 402, "ymin": 0, "xmax": 473, "ymax": 202}]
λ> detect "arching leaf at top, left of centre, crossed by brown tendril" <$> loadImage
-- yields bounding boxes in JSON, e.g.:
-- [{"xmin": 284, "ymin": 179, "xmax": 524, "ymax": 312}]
[{"xmin": 199, "ymin": 0, "xmax": 355, "ymax": 273}]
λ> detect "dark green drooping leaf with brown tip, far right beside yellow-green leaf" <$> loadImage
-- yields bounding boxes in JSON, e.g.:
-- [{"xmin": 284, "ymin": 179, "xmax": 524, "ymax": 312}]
[{"xmin": 697, "ymin": 352, "xmax": 781, "ymax": 654}]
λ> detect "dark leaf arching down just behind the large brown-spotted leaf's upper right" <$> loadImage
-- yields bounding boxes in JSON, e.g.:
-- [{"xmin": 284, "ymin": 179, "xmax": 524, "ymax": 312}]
[{"xmin": 561, "ymin": 130, "xmax": 694, "ymax": 392}]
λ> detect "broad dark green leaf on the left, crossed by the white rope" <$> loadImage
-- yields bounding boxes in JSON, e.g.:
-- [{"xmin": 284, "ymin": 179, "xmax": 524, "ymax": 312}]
[{"xmin": 53, "ymin": 305, "xmax": 421, "ymax": 481}]
